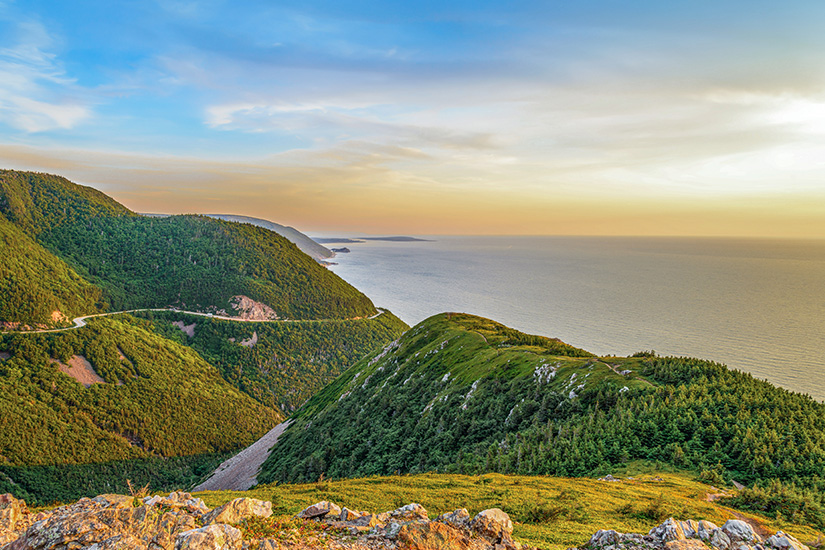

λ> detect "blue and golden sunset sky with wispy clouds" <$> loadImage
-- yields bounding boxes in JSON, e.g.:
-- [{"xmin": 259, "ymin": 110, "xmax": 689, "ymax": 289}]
[{"xmin": 0, "ymin": 0, "xmax": 825, "ymax": 238}]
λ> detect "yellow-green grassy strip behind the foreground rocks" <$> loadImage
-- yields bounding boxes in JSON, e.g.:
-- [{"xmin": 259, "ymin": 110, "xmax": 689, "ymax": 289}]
[{"xmin": 198, "ymin": 470, "xmax": 823, "ymax": 550}]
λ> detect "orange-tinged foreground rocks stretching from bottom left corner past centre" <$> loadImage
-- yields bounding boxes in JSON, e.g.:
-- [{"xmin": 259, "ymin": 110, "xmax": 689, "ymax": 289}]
[{"xmin": 0, "ymin": 492, "xmax": 536, "ymax": 550}]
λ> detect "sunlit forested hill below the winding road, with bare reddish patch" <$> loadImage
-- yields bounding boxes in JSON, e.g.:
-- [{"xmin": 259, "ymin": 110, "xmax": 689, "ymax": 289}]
[{"xmin": 0, "ymin": 317, "xmax": 283, "ymax": 504}]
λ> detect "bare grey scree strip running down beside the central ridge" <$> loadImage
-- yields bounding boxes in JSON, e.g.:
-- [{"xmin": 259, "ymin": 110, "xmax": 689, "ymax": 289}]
[{"xmin": 192, "ymin": 420, "xmax": 291, "ymax": 493}]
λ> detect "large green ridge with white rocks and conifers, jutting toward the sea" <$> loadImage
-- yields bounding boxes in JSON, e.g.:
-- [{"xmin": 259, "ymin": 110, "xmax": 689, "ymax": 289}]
[{"xmin": 259, "ymin": 314, "xmax": 825, "ymax": 525}]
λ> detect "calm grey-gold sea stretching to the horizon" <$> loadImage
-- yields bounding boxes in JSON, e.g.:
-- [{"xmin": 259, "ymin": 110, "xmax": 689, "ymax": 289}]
[{"xmin": 328, "ymin": 237, "xmax": 825, "ymax": 401}]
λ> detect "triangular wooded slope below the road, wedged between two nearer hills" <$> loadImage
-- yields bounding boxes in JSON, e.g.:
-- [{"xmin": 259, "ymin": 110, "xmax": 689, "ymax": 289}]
[{"xmin": 140, "ymin": 311, "xmax": 409, "ymax": 413}]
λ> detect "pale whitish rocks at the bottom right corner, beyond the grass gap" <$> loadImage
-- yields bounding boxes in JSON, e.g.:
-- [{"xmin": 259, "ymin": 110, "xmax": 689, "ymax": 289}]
[{"xmin": 585, "ymin": 518, "xmax": 810, "ymax": 550}]
